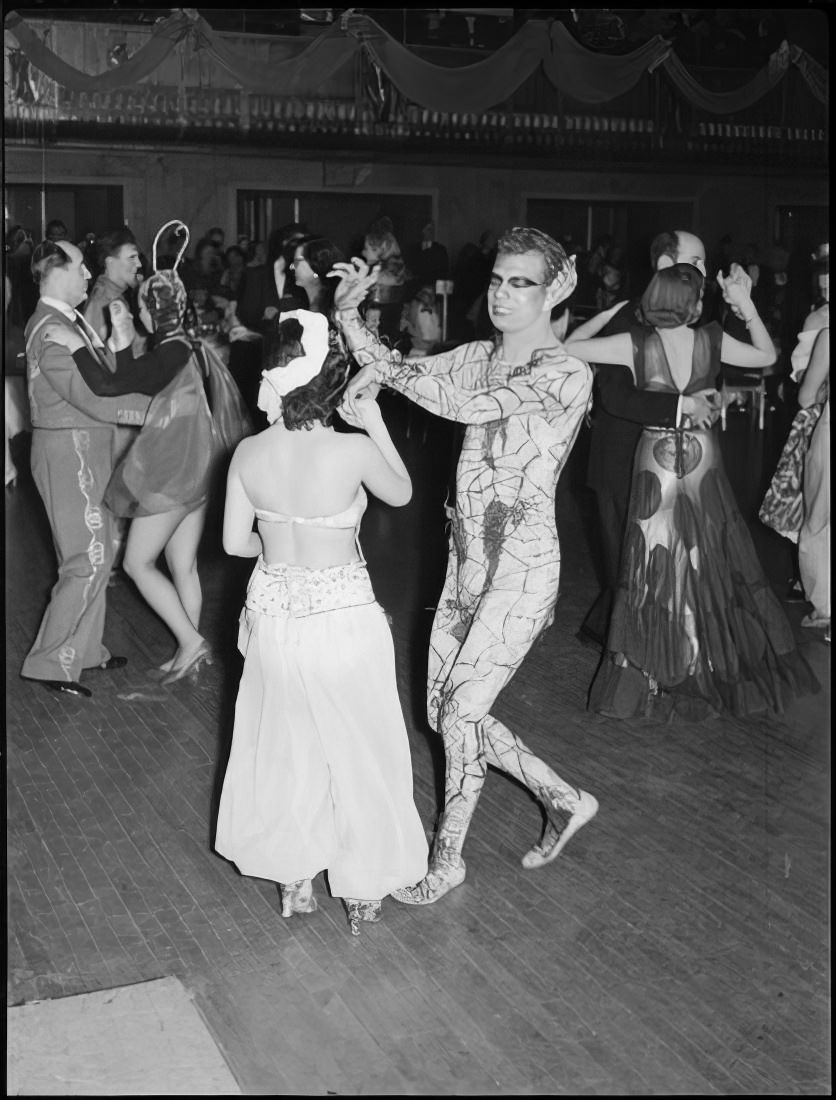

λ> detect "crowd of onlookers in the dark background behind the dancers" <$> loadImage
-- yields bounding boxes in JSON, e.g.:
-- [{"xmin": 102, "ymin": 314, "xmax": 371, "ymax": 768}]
[{"xmin": 4, "ymin": 213, "xmax": 815, "ymax": 373}]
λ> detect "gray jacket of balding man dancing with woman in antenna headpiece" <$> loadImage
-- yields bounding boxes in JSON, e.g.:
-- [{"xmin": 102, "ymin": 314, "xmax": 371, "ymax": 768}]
[{"xmin": 24, "ymin": 300, "xmax": 151, "ymax": 428}]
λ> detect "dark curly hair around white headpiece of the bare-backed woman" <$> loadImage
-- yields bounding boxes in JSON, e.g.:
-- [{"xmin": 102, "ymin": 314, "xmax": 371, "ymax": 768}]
[{"xmin": 262, "ymin": 317, "xmax": 349, "ymax": 431}]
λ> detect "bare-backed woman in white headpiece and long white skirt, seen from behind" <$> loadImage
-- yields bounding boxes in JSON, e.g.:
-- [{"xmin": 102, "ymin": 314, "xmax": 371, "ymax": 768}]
[{"xmin": 215, "ymin": 310, "xmax": 428, "ymax": 935}]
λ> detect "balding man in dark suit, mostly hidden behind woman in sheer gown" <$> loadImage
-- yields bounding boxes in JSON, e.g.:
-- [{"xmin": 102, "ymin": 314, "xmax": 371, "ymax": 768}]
[{"xmin": 573, "ymin": 230, "xmax": 718, "ymax": 647}]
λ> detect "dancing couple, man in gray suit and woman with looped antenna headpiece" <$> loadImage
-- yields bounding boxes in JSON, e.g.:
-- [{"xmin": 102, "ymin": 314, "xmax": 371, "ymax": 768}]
[{"xmin": 22, "ymin": 220, "xmax": 255, "ymax": 697}]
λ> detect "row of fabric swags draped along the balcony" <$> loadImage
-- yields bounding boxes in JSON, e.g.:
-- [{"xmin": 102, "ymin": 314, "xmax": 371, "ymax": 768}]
[{"xmin": 4, "ymin": 9, "xmax": 828, "ymax": 114}]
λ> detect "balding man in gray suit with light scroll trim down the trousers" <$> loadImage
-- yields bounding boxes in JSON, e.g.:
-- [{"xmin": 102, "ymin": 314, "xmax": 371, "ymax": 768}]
[{"xmin": 21, "ymin": 241, "xmax": 150, "ymax": 696}]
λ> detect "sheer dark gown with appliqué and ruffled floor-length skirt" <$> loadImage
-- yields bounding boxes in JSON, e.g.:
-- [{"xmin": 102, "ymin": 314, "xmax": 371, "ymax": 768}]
[{"xmin": 589, "ymin": 322, "xmax": 820, "ymax": 721}]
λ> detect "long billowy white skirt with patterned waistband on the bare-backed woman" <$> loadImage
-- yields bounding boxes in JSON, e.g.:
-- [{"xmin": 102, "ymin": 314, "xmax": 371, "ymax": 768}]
[{"xmin": 215, "ymin": 559, "xmax": 427, "ymax": 899}]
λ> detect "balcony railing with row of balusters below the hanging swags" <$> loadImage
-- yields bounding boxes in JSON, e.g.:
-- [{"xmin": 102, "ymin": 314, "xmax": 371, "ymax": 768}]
[{"xmin": 6, "ymin": 85, "xmax": 828, "ymax": 167}]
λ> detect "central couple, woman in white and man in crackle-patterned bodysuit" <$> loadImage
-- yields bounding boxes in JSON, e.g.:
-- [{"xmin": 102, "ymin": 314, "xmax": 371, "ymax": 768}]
[{"xmin": 216, "ymin": 229, "xmax": 597, "ymax": 932}]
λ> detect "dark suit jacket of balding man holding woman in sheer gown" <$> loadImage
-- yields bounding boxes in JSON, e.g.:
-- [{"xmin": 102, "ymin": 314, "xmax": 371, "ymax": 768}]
[{"xmin": 586, "ymin": 298, "xmax": 679, "ymax": 501}]
